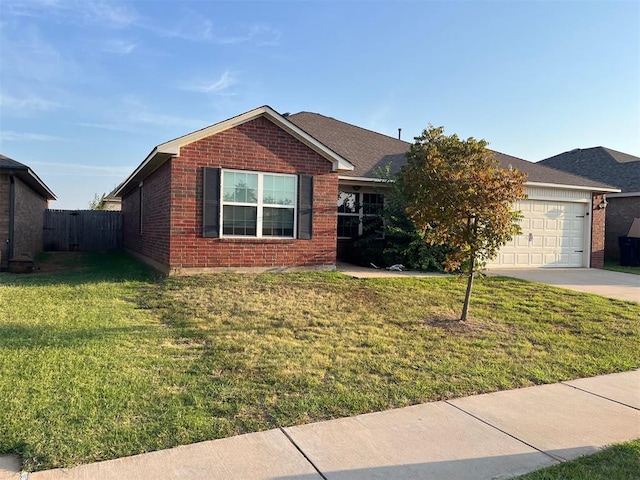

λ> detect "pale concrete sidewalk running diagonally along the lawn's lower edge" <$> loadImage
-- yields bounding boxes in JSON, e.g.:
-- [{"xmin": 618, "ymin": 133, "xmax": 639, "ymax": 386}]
[{"xmin": 6, "ymin": 370, "xmax": 640, "ymax": 480}]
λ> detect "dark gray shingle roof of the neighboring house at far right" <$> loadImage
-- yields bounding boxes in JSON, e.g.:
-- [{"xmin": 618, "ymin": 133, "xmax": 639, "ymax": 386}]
[{"xmin": 538, "ymin": 147, "xmax": 640, "ymax": 192}]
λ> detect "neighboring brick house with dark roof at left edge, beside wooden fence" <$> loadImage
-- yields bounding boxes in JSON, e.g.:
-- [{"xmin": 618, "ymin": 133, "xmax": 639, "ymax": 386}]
[{"xmin": 0, "ymin": 155, "xmax": 56, "ymax": 269}]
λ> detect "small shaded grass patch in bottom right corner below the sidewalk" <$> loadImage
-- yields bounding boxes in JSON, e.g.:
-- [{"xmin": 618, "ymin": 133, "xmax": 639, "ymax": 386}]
[{"xmin": 518, "ymin": 440, "xmax": 640, "ymax": 480}]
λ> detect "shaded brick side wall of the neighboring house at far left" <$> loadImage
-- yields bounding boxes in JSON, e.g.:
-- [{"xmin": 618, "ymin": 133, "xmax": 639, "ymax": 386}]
[{"xmin": 13, "ymin": 177, "xmax": 49, "ymax": 257}]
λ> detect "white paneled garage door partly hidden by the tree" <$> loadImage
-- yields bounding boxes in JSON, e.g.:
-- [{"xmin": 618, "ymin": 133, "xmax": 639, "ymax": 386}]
[{"xmin": 487, "ymin": 200, "xmax": 588, "ymax": 268}]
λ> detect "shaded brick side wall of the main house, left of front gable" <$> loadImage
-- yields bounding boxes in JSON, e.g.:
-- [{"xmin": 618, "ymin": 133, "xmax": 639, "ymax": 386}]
[{"xmin": 122, "ymin": 161, "xmax": 172, "ymax": 265}]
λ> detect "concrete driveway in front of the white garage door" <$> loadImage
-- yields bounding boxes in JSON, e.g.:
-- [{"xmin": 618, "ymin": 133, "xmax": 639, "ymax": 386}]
[{"xmin": 485, "ymin": 268, "xmax": 640, "ymax": 302}]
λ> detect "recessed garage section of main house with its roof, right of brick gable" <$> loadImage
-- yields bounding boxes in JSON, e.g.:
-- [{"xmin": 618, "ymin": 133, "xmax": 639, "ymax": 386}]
[{"xmin": 287, "ymin": 112, "xmax": 617, "ymax": 268}]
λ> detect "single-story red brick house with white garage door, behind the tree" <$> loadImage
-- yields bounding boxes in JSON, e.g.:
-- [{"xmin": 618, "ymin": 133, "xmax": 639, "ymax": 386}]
[{"xmin": 114, "ymin": 106, "xmax": 615, "ymax": 274}]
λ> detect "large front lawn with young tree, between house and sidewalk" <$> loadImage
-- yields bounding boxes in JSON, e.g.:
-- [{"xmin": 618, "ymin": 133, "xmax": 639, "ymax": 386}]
[{"xmin": 0, "ymin": 253, "xmax": 640, "ymax": 471}]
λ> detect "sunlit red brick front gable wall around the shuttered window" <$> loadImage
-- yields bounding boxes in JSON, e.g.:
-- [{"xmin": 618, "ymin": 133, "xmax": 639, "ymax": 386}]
[{"xmin": 170, "ymin": 118, "xmax": 338, "ymax": 269}]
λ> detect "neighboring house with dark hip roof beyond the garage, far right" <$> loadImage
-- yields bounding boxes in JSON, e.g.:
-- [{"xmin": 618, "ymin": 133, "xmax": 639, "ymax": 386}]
[{"xmin": 538, "ymin": 147, "xmax": 640, "ymax": 258}]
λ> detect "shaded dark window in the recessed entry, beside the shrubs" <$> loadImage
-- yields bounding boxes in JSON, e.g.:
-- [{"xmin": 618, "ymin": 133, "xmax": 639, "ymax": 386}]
[{"xmin": 338, "ymin": 191, "xmax": 384, "ymax": 238}]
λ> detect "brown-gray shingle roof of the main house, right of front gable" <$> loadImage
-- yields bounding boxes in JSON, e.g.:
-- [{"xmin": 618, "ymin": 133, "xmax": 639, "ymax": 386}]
[{"xmin": 287, "ymin": 112, "xmax": 610, "ymax": 190}]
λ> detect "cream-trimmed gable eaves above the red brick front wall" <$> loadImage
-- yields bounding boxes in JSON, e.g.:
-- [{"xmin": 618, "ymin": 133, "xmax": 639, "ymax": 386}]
[{"xmin": 114, "ymin": 105, "xmax": 353, "ymax": 196}]
